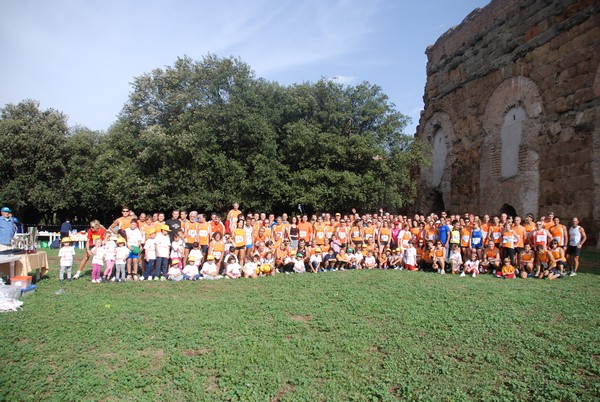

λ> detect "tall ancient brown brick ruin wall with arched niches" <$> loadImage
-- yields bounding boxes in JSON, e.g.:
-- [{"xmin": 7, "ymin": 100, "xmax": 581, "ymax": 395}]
[{"xmin": 416, "ymin": 0, "xmax": 600, "ymax": 247}]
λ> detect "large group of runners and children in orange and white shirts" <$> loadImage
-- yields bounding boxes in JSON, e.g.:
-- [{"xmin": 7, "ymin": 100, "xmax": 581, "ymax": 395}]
[{"xmin": 59, "ymin": 204, "xmax": 586, "ymax": 283}]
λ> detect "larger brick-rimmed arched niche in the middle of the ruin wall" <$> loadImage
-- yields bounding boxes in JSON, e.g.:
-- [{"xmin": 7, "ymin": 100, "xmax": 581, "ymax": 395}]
[{"xmin": 479, "ymin": 76, "xmax": 542, "ymax": 215}]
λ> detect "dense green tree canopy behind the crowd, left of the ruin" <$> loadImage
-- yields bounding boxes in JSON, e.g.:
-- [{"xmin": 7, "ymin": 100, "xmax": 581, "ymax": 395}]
[{"xmin": 0, "ymin": 55, "xmax": 432, "ymax": 225}]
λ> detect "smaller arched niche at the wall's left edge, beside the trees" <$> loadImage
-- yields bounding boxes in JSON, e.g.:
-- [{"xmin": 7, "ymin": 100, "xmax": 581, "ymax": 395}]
[{"xmin": 421, "ymin": 112, "xmax": 456, "ymax": 210}]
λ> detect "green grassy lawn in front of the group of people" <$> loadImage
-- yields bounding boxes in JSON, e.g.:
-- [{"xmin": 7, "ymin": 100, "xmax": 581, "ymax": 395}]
[{"xmin": 0, "ymin": 251, "xmax": 600, "ymax": 401}]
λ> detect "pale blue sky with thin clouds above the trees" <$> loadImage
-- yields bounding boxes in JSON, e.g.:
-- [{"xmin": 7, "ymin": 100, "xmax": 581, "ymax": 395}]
[{"xmin": 0, "ymin": 0, "xmax": 489, "ymax": 134}]
